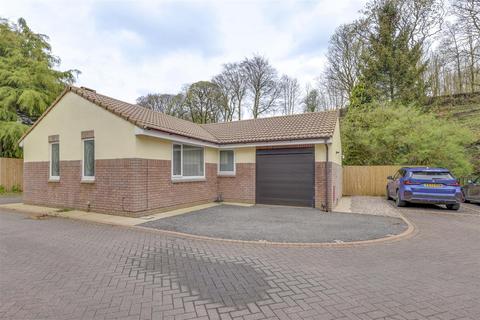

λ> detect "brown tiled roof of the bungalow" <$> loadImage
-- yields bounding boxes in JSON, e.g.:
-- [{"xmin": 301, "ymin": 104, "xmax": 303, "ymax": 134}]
[{"xmin": 20, "ymin": 86, "xmax": 338, "ymax": 144}]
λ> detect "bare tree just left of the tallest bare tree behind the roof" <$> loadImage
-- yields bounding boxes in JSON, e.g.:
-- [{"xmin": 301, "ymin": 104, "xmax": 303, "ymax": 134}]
[{"xmin": 212, "ymin": 63, "xmax": 247, "ymax": 121}]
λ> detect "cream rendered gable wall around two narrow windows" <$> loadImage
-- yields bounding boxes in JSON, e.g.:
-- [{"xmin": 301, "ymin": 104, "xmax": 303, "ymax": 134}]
[{"xmin": 23, "ymin": 92, "xmax": 136, "ymax": 162}]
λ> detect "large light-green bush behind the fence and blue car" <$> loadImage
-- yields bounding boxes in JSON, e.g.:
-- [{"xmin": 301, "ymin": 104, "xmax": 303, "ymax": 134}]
[{"xmin": 342, "ymin": 103, "xmax": 475, "ymax": 176}]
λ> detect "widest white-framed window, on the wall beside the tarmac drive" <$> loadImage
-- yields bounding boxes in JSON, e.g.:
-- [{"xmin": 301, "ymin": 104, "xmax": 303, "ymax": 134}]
[{"xmin": 172, "ymin": 144, "xmax": 205, "ymax": 179}]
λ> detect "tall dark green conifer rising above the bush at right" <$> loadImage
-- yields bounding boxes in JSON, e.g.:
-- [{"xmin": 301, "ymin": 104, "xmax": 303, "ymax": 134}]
[{"xmin": 360, "ymin": 0, "xmax": 427, "ymax": 105}]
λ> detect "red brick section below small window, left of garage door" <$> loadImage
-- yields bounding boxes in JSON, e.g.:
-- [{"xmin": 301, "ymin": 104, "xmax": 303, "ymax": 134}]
[{"xmin": 217, "ymin": 163, "xmax": 255, "ymax": 203}]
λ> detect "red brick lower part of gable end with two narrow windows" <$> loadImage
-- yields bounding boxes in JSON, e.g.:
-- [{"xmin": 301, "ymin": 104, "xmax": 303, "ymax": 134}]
[{"xmin": 23, "ymin": 159, "xmax": 142, "ymax": 214}]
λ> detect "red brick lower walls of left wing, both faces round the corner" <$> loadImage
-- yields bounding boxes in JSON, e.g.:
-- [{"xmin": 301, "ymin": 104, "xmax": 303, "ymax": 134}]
[{"xmin": 24, "ymin": 159, "xmax": 217, "ymax": 215}]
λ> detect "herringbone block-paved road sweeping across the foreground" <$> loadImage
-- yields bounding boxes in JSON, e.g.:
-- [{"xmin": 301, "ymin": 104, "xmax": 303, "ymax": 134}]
[{"xmin": 0, "ymin": 204, "xmax": 480, "ymax": 320}]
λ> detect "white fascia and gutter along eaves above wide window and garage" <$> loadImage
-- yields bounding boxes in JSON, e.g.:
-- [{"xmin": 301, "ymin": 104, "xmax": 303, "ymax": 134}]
[{"xmin": 135, "ymin": 127, "xmax": 332, "ymax": 149}]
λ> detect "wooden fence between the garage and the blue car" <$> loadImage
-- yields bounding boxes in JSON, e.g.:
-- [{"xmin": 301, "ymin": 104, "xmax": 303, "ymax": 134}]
[{"xmin": 343, "ymin": 166, "xmax": 402, "ymax": 196}]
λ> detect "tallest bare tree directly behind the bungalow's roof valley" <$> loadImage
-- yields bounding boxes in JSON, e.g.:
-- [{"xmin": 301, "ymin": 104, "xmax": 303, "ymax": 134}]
[{"xmin": 241, "ymin": 55, "xmax": 280, "ymax": 119}]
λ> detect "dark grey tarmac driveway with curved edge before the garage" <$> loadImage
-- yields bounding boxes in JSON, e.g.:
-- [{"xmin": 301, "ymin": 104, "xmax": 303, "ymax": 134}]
[{"xmin": 142, "ymin": 205, "xmax": 407, "ymax": 242}]
